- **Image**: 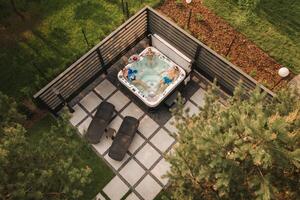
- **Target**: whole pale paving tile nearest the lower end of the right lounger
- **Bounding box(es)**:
[120,159,145,186]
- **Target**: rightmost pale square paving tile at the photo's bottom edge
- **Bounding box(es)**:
[135,175,162,200]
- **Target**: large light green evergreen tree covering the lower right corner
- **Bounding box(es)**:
[168,86,300,200]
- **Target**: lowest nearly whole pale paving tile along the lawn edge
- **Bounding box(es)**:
[103,176,129,200]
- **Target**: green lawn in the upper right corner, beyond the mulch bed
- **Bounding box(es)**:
[204,0,300,74]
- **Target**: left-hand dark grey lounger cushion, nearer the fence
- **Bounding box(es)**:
[85,102,115,144]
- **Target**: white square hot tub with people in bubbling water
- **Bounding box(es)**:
[118,47,186,108]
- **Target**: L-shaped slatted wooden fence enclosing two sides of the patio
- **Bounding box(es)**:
[34,7,274,114]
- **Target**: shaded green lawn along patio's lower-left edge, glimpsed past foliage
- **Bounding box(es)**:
[28,115,114,200]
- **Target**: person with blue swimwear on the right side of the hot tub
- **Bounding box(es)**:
[157,65,179,93]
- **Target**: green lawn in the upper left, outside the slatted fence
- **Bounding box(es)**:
[0,0,160,98]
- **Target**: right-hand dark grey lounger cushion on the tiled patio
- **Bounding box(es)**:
[108,116,139,161]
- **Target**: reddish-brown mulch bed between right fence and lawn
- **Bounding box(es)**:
[158,0,293,91]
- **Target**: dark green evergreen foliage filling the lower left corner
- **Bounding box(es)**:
[0,93,91,200]
